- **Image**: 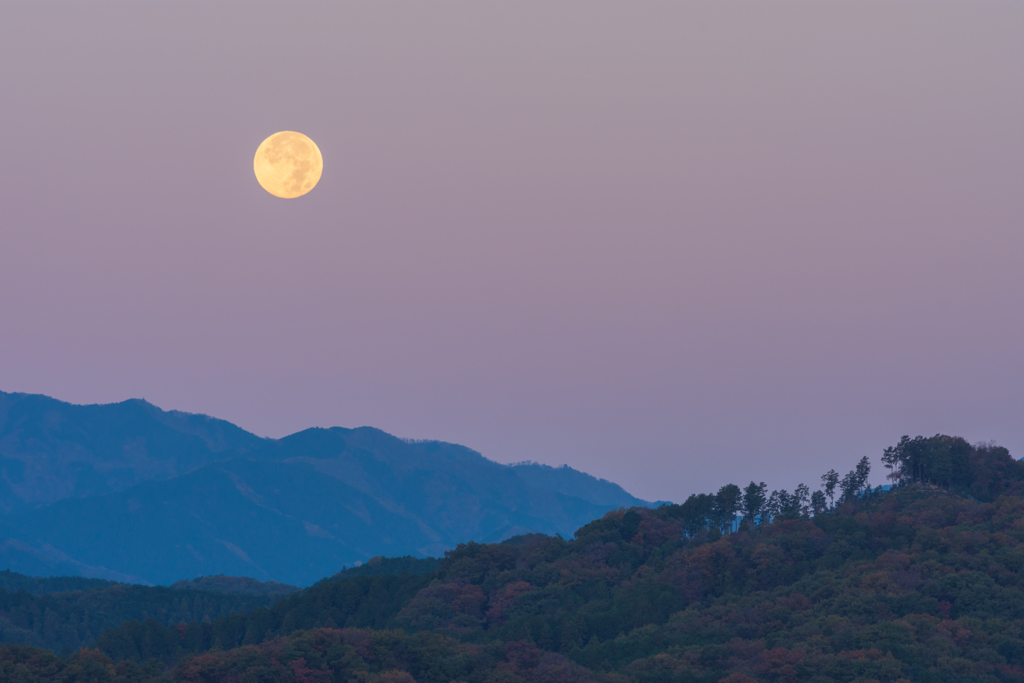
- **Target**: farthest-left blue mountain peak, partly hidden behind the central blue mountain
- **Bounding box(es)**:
[0,392,264,512]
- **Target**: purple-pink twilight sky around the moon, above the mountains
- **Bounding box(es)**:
[0,0,1024,501]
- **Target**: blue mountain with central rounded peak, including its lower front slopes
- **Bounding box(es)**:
[6,436,612,586]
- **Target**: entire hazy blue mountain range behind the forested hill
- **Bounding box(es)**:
[0,392,651,586]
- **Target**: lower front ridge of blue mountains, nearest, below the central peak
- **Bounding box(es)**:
[9,459,428,585]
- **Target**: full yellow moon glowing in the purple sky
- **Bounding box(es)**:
[253,130,324,200]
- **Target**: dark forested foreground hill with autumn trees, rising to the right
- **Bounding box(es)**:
[9,436,1024,683]
